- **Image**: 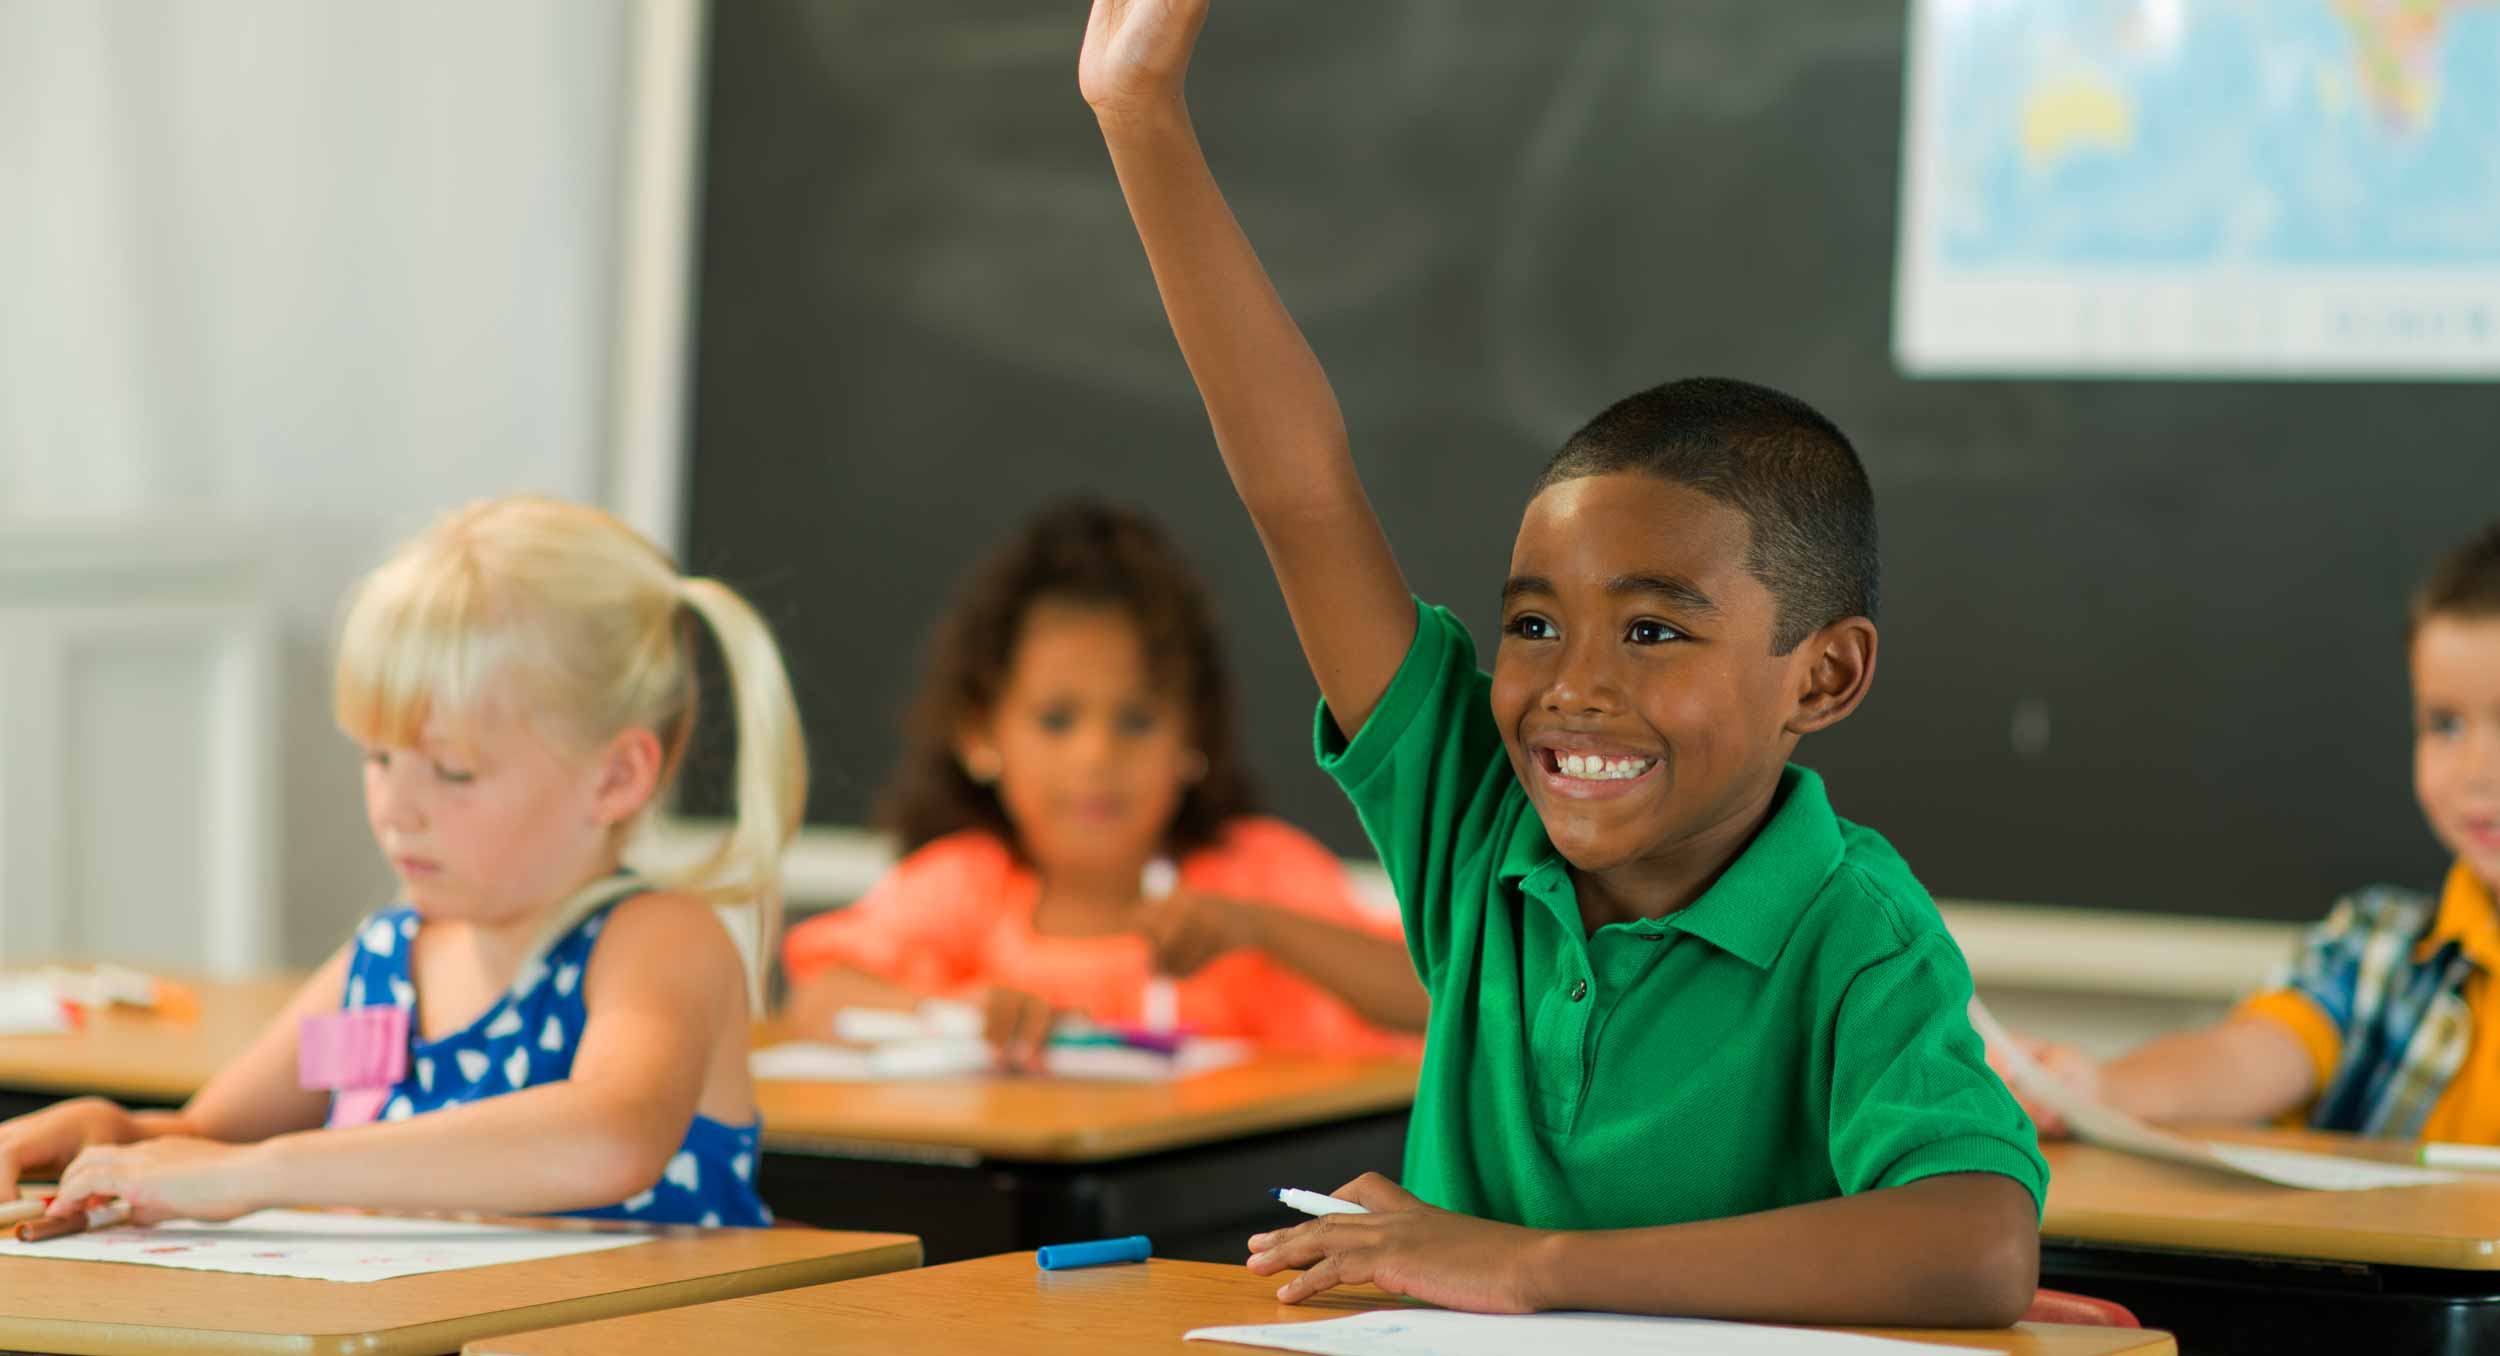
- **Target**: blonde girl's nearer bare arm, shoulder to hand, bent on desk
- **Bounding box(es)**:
[55,896,745,1221]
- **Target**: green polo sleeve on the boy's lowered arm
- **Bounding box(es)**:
[1830,931,2048,1208]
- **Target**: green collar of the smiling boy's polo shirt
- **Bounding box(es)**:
[1495,763,1843,971]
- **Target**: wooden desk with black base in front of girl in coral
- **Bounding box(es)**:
[758,1058,1415,1261]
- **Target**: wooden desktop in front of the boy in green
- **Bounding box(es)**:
[468,1253,2175,1356]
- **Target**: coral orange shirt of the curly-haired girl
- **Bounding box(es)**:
[783,818,1423,1056]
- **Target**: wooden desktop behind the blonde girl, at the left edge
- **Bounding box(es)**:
[0,976,305,1118]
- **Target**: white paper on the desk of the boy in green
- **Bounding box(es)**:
[1183,1308,2003,1356]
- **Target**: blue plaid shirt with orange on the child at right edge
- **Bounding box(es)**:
[2243,863,2495,1138]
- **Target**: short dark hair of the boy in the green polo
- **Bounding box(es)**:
[1538,378,1878,655]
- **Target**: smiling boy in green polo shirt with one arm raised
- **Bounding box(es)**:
[1080,0,2048,1326]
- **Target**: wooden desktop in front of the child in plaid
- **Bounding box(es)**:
[2040,1128,2500,1271]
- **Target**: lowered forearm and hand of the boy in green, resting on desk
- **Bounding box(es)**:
[1250,1173,2040,1328]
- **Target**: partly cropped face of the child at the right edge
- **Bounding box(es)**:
[2413,615,2500,888]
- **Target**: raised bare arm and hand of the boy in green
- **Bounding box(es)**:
[1078,0,1415,738]
